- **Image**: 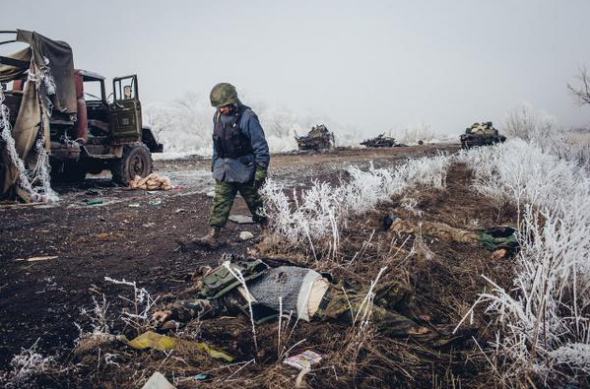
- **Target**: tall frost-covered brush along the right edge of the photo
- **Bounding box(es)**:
[458,140,590,384]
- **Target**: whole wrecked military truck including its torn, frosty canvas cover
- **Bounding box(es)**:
[0,30,163,201]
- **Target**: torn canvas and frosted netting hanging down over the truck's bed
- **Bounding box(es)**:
[0,30,77,202]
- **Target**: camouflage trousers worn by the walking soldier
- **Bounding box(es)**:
[209,181,266,227]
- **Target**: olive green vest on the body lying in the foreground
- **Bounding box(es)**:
[199,259,268,299]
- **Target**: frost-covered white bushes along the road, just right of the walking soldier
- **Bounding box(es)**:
[262,155,450,256]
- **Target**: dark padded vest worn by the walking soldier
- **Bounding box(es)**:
[213,104,252,159]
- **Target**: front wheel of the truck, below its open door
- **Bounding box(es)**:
[111,143,153,185]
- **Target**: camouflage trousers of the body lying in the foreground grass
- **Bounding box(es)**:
[314,281,446,345]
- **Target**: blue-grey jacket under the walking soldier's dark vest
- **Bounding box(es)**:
[212,103,270,184]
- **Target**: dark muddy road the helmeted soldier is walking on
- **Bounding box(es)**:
[0,145,458,369]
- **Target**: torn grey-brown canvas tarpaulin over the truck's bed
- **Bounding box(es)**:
[0,30,77,202]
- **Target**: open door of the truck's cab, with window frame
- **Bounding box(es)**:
[109,75,141,143]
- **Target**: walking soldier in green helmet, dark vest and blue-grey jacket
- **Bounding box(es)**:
[196,83,270,249]
